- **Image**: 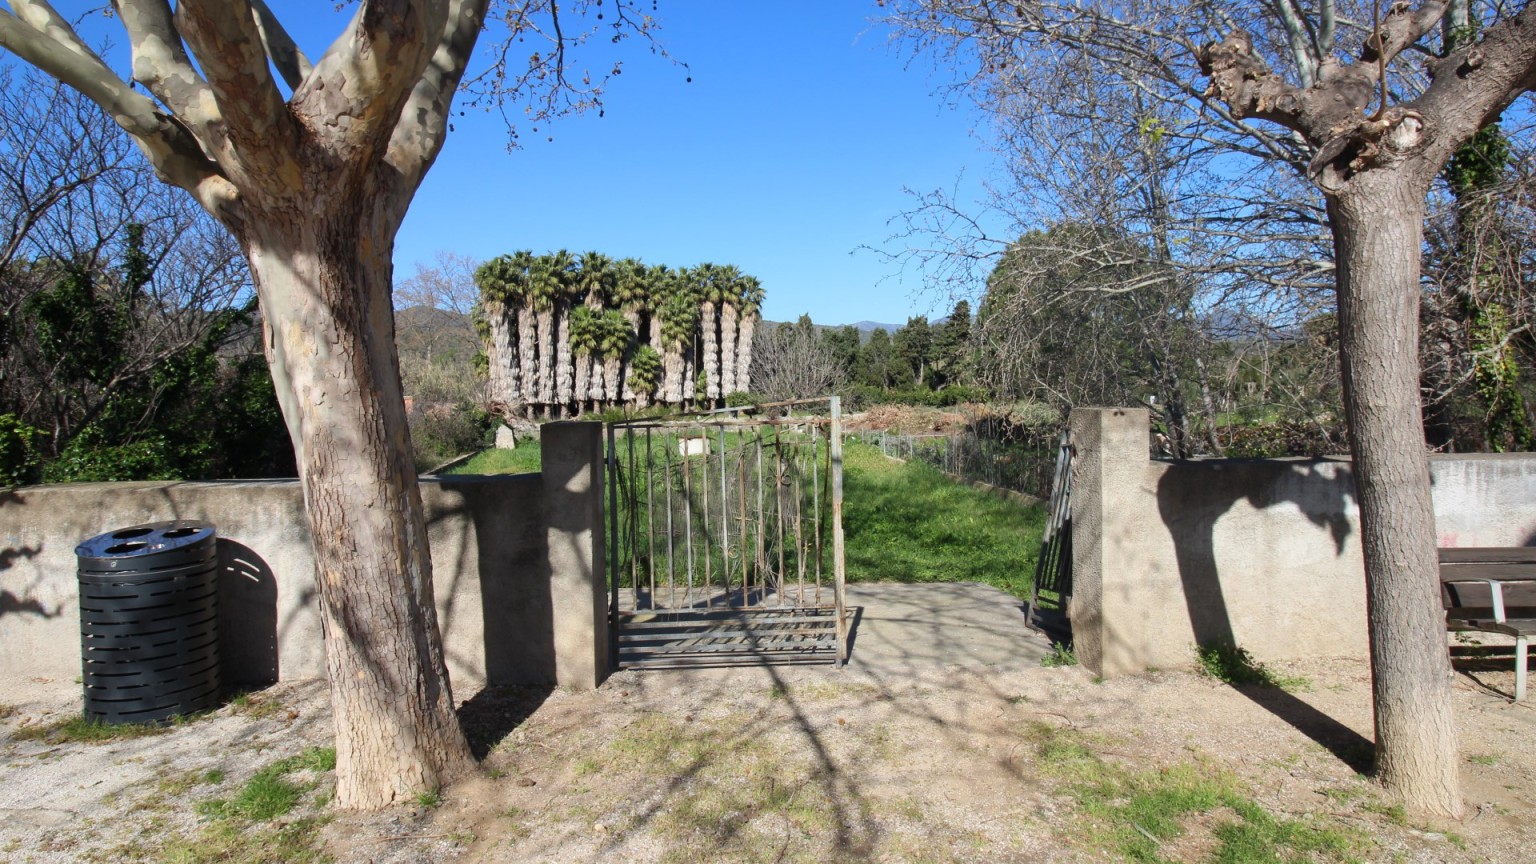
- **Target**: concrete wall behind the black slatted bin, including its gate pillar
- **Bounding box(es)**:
[0,423,608,696]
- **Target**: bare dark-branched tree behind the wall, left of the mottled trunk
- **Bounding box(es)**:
[0,68,250,457]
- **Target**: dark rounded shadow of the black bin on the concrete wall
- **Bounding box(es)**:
[218,537,278,687]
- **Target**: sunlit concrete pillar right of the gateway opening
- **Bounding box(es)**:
[1068,407,1157,678]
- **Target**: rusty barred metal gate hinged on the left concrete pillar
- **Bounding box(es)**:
[607,397,848,667]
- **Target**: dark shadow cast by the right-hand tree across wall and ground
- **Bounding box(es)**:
[1157,460,1372,770]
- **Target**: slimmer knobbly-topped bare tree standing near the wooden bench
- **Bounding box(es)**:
[895,0,1536,816]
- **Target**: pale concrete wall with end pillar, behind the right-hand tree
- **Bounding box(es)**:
[1071,409,1536,676]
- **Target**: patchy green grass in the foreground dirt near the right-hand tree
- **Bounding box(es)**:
[1025,723,1364,864]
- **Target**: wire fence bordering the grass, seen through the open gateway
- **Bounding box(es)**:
[862,430,1058,498]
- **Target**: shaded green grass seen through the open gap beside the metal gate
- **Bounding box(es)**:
[843,441,1046,598]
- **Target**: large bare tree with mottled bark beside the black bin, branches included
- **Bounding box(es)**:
[0,0,666,807]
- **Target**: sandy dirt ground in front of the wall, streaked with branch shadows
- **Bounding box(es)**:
[0,586,1536,864]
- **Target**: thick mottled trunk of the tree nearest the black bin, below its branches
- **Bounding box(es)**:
[241,209,473,809]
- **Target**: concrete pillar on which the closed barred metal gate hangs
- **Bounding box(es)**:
[539,423,608,690]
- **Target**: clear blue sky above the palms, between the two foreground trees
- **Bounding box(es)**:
[327,0,991,324]
